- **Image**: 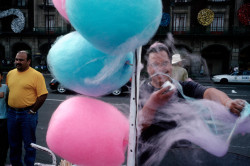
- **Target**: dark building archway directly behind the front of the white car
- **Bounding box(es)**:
[201,44,231,75]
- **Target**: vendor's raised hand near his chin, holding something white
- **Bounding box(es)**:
[146,86,176,110]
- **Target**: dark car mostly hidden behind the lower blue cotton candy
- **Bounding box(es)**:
[49,79,131,96]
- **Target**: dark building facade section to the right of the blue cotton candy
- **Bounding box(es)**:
[153,0,250,76]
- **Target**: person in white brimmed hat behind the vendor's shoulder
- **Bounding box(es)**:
[172,54,188,81]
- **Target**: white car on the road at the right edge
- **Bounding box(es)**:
[212,70,250,83]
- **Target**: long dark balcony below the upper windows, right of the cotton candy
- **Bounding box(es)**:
[156,26,250,36]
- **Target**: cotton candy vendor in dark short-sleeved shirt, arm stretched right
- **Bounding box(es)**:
[138,43,245,165]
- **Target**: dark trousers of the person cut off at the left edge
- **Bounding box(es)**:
[0,119,9,166]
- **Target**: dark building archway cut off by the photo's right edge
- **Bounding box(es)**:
[238,45,250,70]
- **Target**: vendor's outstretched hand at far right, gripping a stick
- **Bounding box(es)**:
[225,99,246,116]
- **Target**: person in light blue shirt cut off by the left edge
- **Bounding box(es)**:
[0,70,9,166]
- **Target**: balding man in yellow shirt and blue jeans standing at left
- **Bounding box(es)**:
[6,51,48,166]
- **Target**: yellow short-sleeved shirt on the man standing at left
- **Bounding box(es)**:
[6,67,48,108]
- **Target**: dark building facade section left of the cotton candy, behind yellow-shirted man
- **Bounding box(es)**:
[0,0,72,70]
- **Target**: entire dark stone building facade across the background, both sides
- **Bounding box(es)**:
[0,0,250,76]
